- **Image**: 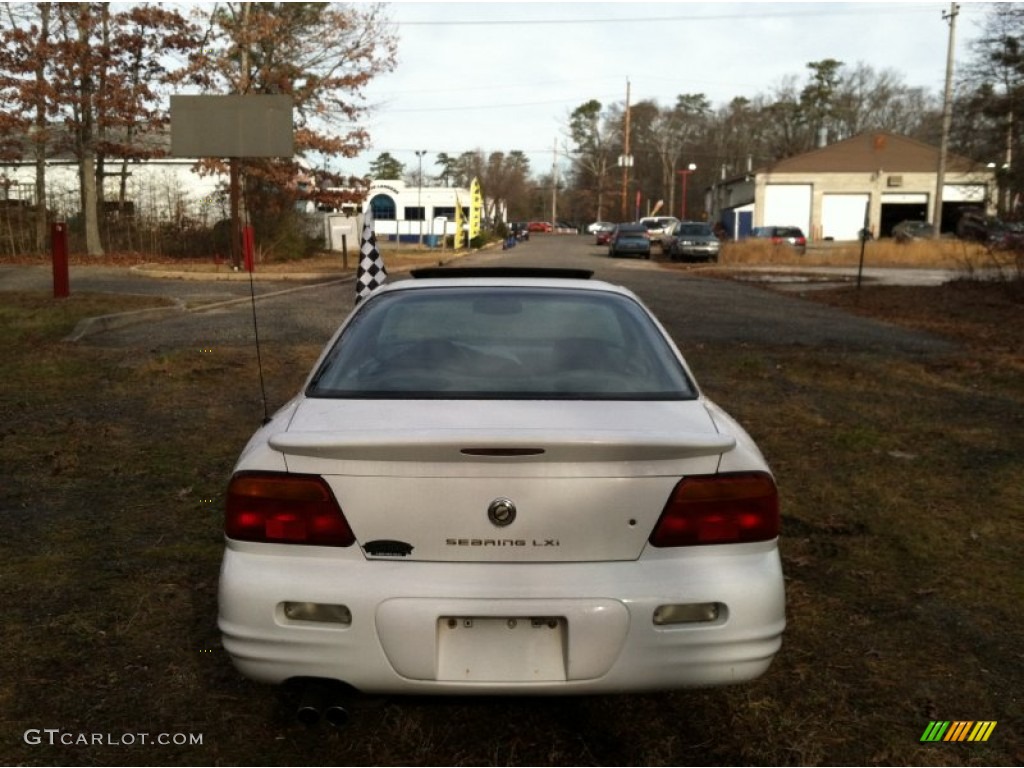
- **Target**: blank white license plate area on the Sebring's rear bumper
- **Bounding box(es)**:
[436,616,567,683]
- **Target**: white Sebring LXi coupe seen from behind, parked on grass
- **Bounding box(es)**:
[219,268,785,722]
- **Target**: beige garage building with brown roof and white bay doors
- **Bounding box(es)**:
[706,131,995,242]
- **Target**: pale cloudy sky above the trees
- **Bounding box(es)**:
[344,0,989,180]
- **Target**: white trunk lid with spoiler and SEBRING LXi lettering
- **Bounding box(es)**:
[270,399,735,561]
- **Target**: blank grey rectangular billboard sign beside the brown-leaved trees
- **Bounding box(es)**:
[171,94,295,158]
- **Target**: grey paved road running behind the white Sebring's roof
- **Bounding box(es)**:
[0,236,951,354]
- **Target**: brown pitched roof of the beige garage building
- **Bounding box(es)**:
[761,131,982,173]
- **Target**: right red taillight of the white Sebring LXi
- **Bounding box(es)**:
[649,472,779,547]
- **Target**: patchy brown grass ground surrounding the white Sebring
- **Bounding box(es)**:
[0,268,1024,765]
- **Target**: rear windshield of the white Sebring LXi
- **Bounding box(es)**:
[306,286,696,399]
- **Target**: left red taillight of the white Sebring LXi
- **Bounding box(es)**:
[224,472,355,547]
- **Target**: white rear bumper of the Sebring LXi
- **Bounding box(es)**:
[218,542,785,694]
